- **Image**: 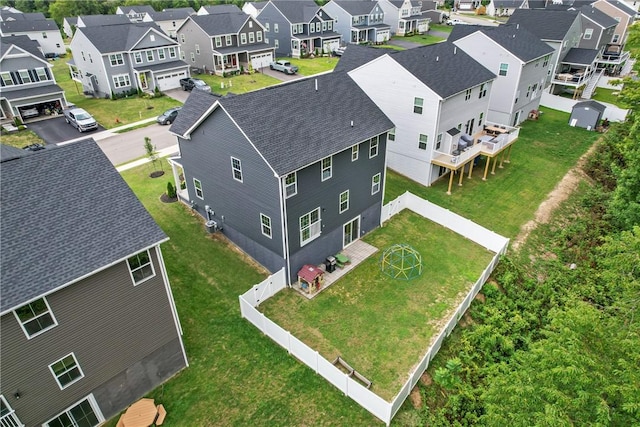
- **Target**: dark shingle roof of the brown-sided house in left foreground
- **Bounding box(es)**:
[0,139,167,313]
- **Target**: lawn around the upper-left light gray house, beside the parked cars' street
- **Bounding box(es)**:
[53,56,181,129]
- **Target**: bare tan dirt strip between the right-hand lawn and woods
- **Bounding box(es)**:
[511,142,597,250]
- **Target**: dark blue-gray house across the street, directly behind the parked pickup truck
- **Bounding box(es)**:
[257,0,343,58]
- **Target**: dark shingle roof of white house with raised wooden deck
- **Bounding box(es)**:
[390,42,496,98]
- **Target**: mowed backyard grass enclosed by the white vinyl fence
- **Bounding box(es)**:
[259,210,493,400]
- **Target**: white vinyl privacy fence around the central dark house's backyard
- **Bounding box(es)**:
[239,192,509,425]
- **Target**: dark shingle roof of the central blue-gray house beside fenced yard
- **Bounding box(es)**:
[170,72,394,176]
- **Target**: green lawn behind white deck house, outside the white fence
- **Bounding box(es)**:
[385,108,600,238]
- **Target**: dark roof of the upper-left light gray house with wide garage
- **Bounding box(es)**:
[77,22,169,53]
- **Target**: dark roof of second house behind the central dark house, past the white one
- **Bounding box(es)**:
[447,24,553,62]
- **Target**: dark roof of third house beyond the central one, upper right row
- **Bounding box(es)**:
[507,9,579,41]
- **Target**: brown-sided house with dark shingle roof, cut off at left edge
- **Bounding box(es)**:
[0,139,187,427]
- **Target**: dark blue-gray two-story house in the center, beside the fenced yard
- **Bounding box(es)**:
[170,72,394,281]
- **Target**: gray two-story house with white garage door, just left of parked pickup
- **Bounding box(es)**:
[177,12,275,76]
